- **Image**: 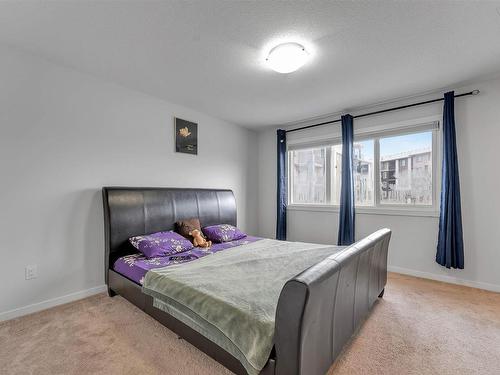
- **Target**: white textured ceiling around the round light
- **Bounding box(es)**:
[0,0,500,128]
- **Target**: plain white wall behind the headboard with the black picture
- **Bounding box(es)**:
[0,46,257,320]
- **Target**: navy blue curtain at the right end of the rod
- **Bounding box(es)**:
[436,91,464,269]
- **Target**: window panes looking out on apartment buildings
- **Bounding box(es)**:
[288,122,438,213]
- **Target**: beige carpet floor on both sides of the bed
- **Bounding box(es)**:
[0,274,500,375]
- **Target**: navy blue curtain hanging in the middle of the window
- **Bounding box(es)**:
[337,115,354,246]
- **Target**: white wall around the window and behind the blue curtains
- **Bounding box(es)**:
[259,79,500,291]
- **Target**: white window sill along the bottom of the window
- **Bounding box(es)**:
[287,204,439,217]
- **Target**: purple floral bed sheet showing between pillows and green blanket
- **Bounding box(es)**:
[113,236,261,285]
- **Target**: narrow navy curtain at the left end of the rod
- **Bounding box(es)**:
[276,129,287,240]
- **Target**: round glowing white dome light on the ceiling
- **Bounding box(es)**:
[266,42,309,73]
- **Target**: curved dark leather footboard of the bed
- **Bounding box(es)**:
[275,229,391,375]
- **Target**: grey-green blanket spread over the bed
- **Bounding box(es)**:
[143,239,342,375]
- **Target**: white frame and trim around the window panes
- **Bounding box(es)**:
[287,116,442,217]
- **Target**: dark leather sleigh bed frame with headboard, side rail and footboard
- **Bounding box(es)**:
[102,187,391,375]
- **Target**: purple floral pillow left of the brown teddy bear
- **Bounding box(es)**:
[128,231,193,258]
